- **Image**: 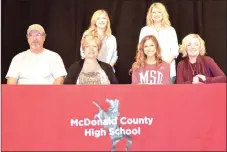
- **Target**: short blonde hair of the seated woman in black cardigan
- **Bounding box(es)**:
[81,35,102,51]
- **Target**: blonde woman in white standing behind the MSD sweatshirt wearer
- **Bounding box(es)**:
[139,3,179,83]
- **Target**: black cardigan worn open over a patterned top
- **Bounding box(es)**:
[64,60,118,84]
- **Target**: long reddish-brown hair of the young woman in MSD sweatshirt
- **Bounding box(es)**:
[130,35,162,72]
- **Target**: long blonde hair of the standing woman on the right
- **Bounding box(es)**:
[146,2,171,27]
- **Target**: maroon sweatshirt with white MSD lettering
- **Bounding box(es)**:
[132,61,170,84]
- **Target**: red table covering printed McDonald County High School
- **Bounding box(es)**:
[2,84,226,151]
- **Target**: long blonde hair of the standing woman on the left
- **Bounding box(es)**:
[84,9,112,36]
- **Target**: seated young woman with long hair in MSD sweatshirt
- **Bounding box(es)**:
[130,35,170,84]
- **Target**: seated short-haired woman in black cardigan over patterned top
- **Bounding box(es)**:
[64,35,118,85]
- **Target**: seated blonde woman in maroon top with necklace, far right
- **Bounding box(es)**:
[177,34,226,84]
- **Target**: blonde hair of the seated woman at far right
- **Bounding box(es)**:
[180,33,206,57]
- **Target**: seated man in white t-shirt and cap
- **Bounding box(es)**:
[6,24,67,84]
